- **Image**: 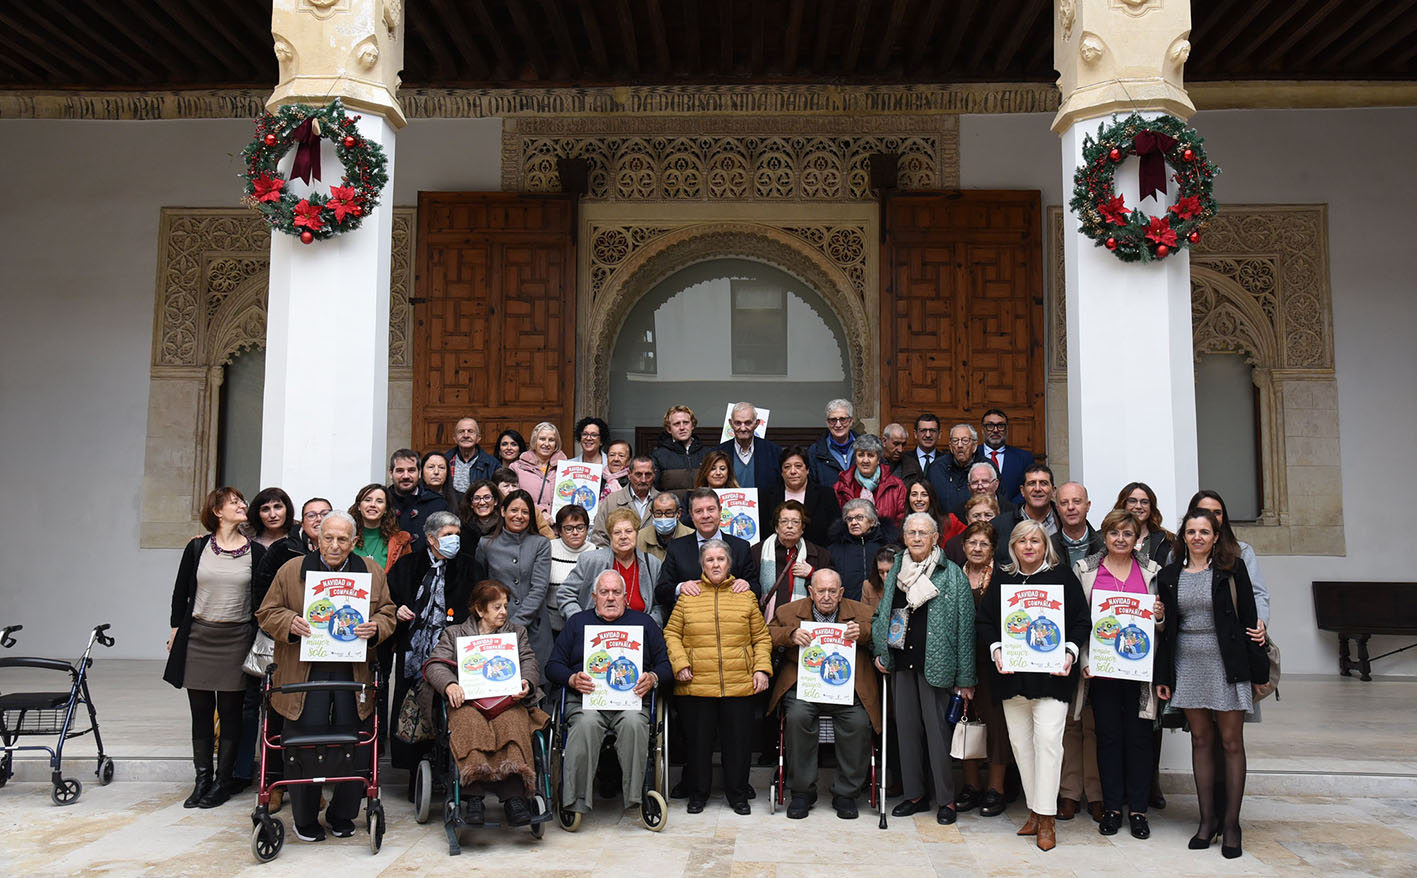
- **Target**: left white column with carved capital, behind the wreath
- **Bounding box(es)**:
[261,0,405,508]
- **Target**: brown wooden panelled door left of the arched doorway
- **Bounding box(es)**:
[412,193,575,452]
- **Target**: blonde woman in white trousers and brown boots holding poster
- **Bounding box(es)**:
[975,518,1091,851]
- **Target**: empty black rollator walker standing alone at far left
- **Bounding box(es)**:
[0,625,113,804]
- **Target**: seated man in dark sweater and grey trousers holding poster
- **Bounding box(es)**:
[546,569,673,814]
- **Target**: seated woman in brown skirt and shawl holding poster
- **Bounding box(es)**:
[424,581,551,826]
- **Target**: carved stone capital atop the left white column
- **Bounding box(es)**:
[266,0,407,129]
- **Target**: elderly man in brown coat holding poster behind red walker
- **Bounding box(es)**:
[256,510,394,841]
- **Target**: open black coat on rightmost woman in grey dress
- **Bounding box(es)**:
[1152,559,1270,688]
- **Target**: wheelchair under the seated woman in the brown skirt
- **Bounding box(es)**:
[414,659,554,857]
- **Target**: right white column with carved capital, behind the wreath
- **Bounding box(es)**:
[1053,0,1197,527]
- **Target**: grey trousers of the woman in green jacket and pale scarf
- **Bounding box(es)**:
[890,671,955,804]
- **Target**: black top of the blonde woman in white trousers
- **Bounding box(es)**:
[975,562,1093,704]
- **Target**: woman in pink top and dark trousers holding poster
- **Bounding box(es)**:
[1073,508,1166,838]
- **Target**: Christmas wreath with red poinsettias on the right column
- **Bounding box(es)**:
[1068,113,1220,262]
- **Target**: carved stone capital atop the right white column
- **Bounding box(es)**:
[1053,0,1196,133]
